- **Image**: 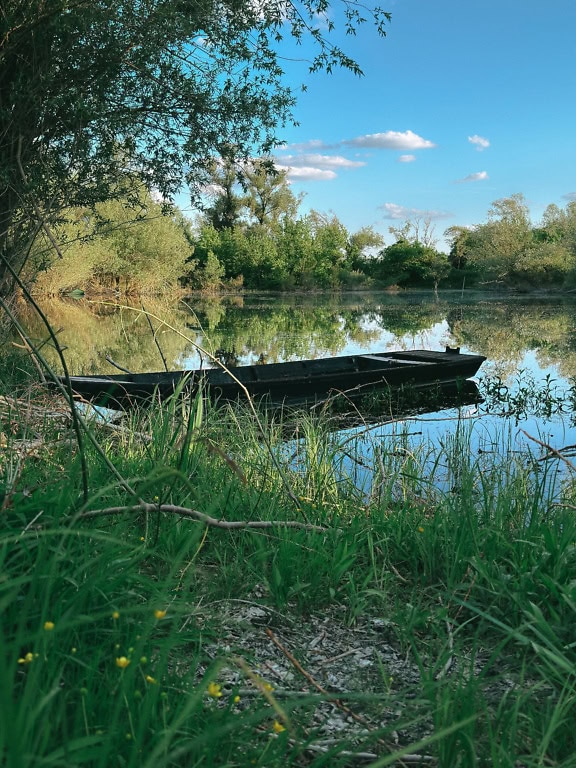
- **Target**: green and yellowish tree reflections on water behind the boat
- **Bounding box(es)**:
[13,294,576,377]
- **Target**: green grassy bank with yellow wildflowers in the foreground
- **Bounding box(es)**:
[0,380,576,768]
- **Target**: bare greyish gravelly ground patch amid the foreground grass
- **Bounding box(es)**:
[189,600,521,768]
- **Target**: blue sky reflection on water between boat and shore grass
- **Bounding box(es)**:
[338,405,574,503]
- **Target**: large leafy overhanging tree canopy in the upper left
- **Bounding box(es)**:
[0,0,389,292]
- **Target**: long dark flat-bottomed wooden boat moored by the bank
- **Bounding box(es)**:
[55,347,486,408]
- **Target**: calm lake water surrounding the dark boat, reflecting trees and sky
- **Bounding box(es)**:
[16,292,576,480]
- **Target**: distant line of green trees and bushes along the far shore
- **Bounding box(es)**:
[27,165,576,294]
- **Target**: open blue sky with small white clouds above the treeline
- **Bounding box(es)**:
[266,0,576,248]
